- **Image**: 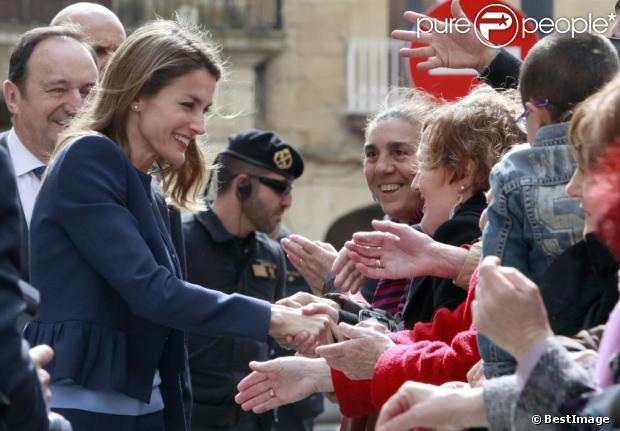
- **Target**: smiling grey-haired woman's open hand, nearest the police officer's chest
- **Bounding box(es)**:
[280,235,338,295]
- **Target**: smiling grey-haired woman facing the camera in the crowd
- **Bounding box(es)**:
[282,88,437,308]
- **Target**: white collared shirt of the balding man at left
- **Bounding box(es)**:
[7,129,45,229]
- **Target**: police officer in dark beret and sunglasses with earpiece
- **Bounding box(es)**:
[183,130,304,431]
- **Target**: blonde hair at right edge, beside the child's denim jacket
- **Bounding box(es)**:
[568,75,620,170]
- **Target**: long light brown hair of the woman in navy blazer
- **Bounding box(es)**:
[52,19,223,210]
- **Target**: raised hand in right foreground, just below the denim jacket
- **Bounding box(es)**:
[472,256,553,360]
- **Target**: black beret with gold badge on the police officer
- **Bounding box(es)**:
[220,129,304,179]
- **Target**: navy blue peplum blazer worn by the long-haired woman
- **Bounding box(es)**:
[25,135,270,429]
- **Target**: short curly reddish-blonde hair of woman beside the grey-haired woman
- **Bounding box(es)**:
[418,90,526,192]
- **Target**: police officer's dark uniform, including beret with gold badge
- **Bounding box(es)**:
[183,130,303,431]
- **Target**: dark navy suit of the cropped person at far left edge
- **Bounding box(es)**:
[0,147,48,431]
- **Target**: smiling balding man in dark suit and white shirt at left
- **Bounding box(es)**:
[0,27,97,280]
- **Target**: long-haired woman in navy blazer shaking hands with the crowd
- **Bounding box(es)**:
[25,20,326,431]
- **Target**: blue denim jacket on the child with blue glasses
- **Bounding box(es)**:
[478,123,584,378]
